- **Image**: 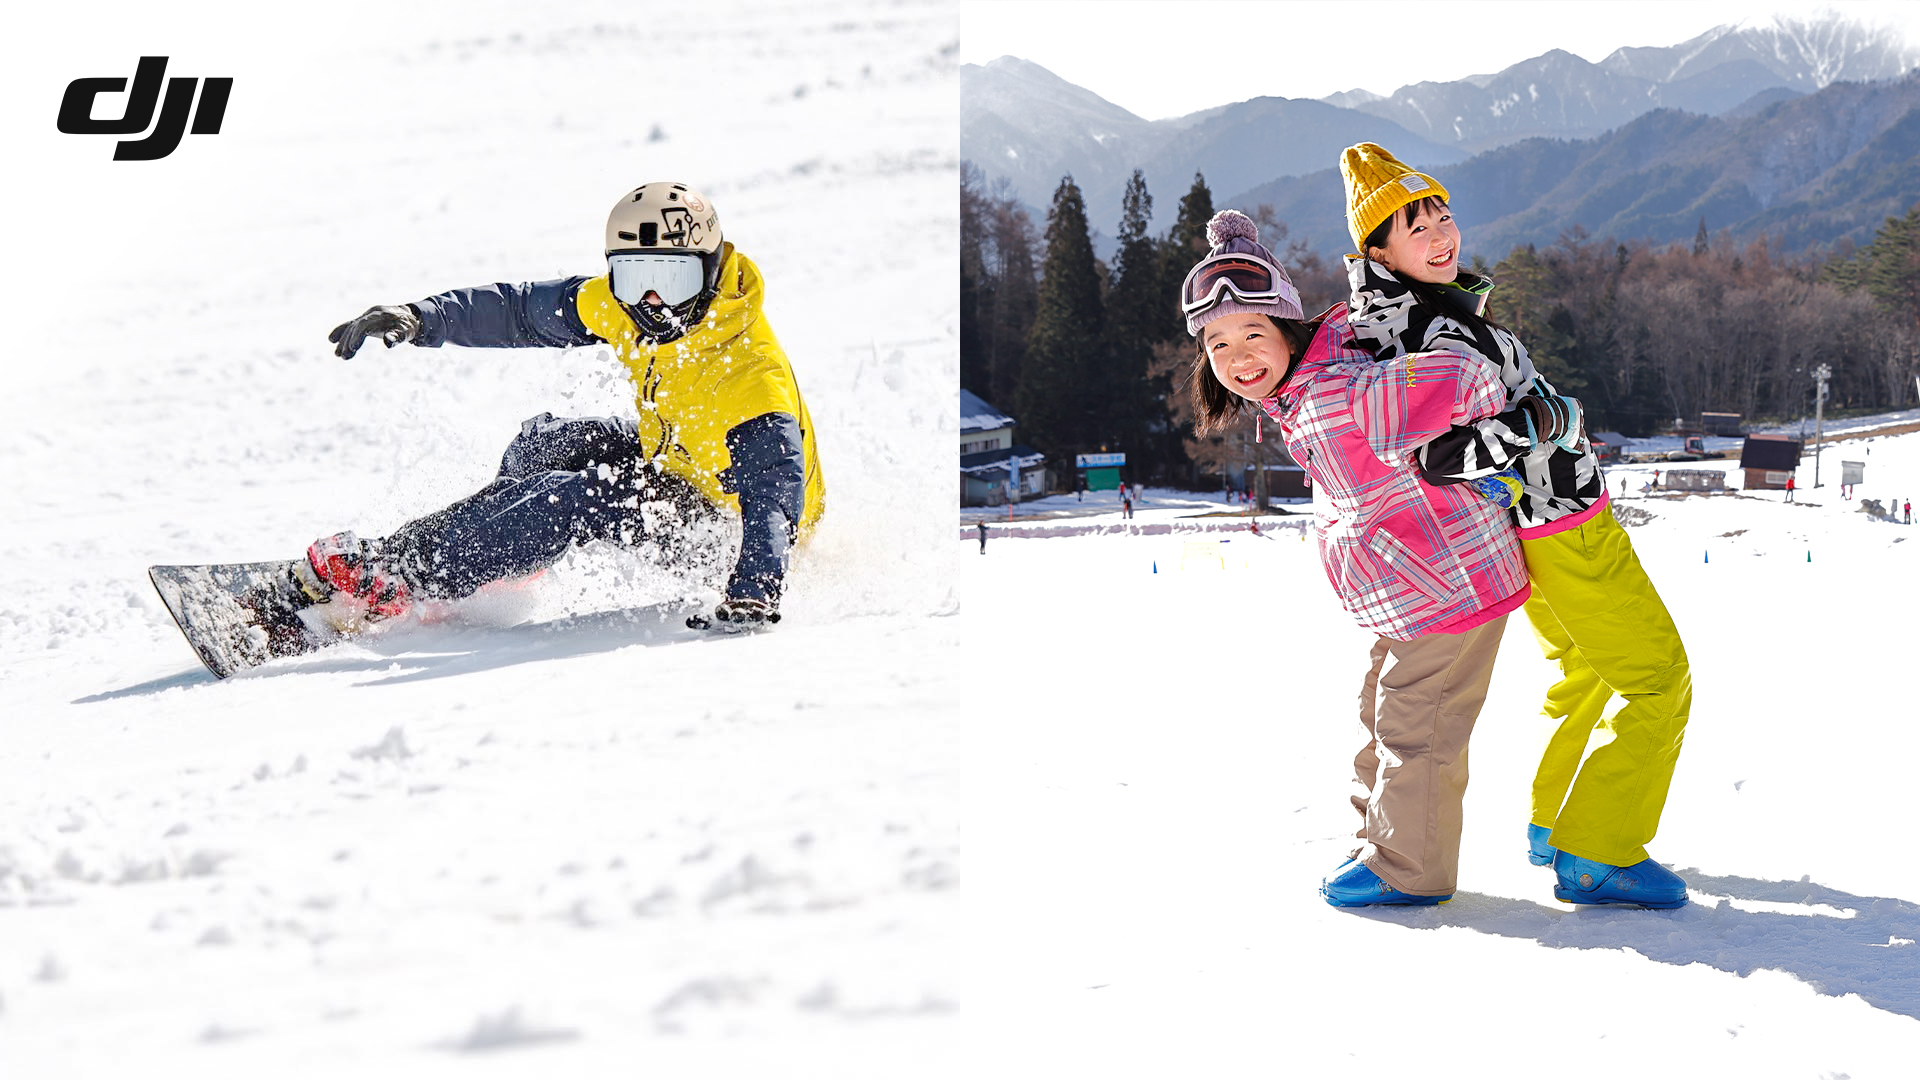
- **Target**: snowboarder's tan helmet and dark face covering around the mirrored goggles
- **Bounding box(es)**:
[607,181,728,342]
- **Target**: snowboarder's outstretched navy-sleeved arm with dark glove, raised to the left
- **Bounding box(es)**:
[328,277,601,359]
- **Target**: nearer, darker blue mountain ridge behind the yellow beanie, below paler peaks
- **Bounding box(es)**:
[1213,71,1920,261]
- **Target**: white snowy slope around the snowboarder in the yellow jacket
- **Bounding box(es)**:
[0,0,964,1078]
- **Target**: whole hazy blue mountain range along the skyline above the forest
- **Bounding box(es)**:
[960,17,1920,258]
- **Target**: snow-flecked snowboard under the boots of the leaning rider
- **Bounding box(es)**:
[146,561,340,678]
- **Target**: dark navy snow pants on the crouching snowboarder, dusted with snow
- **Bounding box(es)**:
[384,413,716,600]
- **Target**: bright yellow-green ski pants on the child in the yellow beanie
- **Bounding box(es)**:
[1521,511,1693,867]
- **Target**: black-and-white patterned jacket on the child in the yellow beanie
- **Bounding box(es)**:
[1346,256,1607,538]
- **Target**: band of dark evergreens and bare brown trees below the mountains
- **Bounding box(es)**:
[960,163,1920,486]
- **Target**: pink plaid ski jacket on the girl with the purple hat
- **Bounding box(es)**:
[1261,304,1528,640]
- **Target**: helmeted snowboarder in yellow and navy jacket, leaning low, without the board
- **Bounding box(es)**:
[312,183,826,626]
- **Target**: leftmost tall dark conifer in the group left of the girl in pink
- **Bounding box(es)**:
[1014,175,1106,457]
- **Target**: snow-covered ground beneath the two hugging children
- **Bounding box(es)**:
[960,424,1920,1080]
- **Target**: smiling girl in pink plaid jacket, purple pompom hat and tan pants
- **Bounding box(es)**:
[1181,209,1528,907]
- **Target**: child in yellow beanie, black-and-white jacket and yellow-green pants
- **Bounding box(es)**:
[1340,142,1693,907]
